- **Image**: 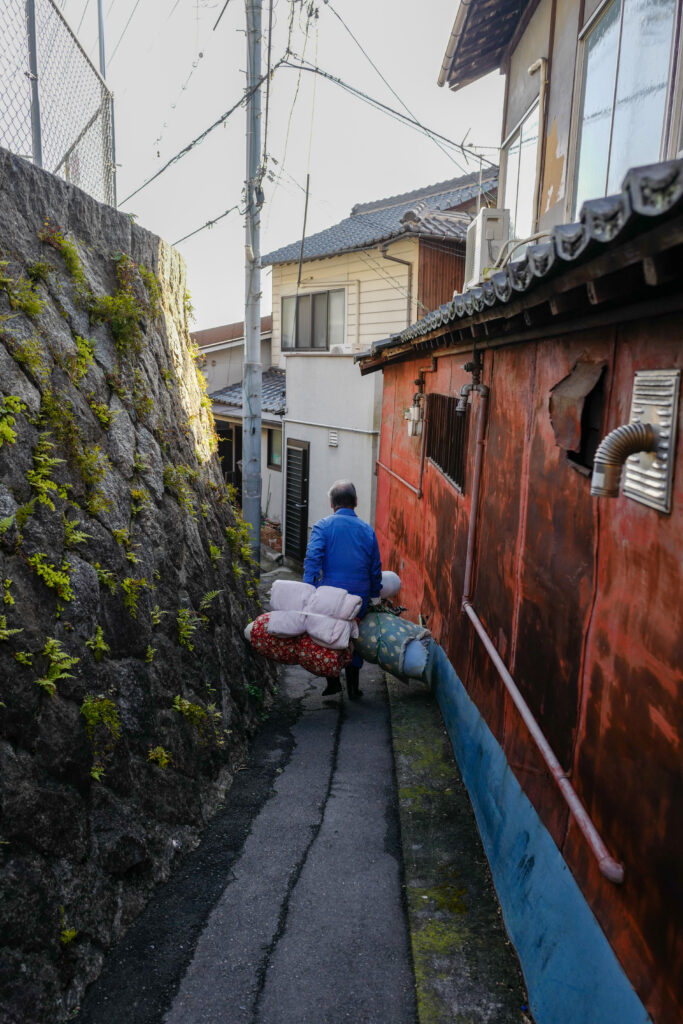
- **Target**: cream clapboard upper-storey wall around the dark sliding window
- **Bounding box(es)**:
[272,239,420,367]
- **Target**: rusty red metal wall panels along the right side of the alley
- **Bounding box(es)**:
[377,317,683,1024]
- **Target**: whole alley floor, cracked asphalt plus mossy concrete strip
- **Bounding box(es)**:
[70,569,528,1024]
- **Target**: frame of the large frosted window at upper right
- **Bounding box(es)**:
[564,0,683,222]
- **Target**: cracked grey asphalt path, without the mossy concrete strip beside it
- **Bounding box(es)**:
[77,666,417,1024]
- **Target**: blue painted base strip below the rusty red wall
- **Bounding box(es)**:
[429,644,651,1024]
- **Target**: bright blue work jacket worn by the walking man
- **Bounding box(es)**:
[303,509,382,614]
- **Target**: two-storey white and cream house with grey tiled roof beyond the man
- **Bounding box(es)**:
[262,167,498,560]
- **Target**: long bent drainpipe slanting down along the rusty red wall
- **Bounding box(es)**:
[461,375,624,884]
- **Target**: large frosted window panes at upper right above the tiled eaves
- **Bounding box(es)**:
[573,0,676,216]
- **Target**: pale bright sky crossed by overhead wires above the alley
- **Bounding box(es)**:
[57,0,504,330]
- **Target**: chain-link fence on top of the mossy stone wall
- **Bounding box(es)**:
[0,0,116,206]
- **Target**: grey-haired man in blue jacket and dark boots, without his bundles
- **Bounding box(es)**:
[303,480,382,700]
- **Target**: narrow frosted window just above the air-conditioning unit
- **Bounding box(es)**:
[504,102,539,240]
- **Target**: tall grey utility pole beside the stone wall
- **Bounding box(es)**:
[242,0,263,566]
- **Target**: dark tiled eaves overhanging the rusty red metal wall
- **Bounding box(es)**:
[355,160,683,375]
